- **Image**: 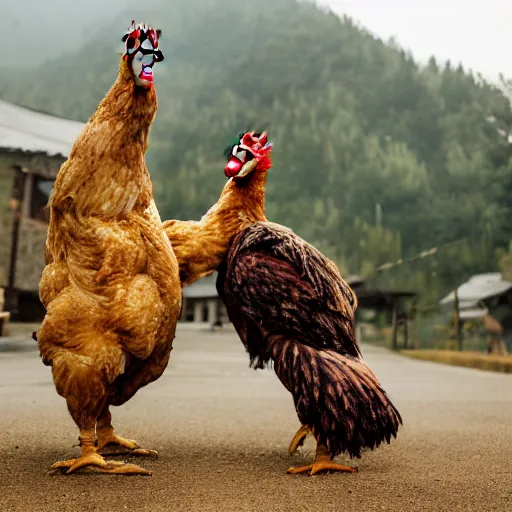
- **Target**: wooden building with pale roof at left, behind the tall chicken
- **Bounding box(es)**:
[0,100,84,321]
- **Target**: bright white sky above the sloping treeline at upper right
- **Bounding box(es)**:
[326,0,512,80]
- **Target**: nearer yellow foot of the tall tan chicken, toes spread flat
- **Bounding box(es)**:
[51,429,151,475]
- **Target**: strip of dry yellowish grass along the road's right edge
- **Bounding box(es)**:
[400,350,512,373]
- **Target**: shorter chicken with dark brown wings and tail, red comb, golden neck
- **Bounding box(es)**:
[166,133,401,474]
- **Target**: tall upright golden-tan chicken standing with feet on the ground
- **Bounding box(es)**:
[37,22,181,474]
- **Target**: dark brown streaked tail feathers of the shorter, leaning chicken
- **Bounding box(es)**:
[269,336,402,457]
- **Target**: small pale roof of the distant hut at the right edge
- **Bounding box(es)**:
[439,272,512,309]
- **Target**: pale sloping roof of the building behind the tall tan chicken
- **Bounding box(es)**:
[0,100,84,157]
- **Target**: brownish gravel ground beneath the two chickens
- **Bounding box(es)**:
[0,328,512,512]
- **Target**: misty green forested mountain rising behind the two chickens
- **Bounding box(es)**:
[0,0,512,300]
